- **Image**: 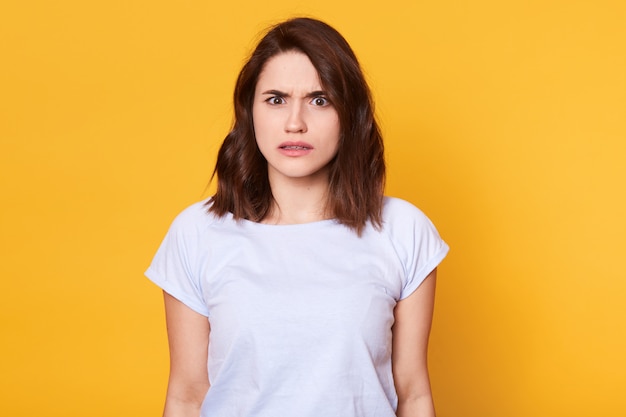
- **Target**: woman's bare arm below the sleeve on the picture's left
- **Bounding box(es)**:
[163,292,210,417]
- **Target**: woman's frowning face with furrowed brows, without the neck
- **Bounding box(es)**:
[252,52,340,185]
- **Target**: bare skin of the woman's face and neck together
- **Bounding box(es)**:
[252,52,340,224]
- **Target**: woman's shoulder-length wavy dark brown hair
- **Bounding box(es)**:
[207,18,385,235]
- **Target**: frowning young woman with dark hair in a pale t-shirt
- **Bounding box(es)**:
[146,18,448,417]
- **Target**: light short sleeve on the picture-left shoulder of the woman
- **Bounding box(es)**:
[145,203,209,317]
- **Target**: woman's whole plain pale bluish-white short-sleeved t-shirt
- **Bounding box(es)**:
[146,197,448,417]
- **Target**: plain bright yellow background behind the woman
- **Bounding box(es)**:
[0,0,626,417]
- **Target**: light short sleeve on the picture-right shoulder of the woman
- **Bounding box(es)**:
[386,199,449,300]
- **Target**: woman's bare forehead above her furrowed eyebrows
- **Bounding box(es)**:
[257,51,321,90]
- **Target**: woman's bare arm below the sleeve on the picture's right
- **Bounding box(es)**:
[391,269,437,417]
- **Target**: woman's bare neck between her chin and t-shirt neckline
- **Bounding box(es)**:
[263,170,332,224]
